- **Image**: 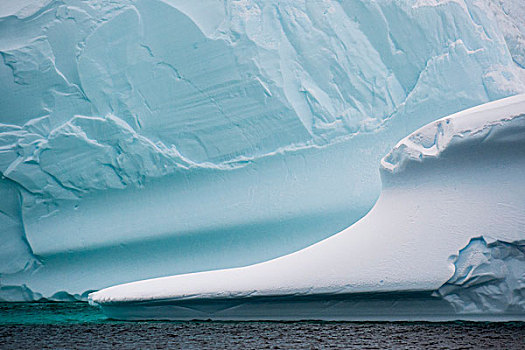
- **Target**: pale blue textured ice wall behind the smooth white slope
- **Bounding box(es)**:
[0,0,525,299]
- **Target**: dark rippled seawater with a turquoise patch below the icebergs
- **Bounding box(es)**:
[0,303,525,349]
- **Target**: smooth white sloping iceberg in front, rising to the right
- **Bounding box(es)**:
[89,95,525,320]
